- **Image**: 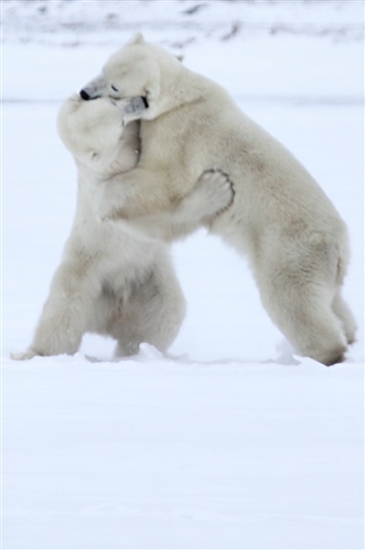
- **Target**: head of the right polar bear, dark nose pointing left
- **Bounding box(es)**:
[80,34,182,121]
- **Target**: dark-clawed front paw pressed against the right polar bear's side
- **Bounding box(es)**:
[196,170,235,221]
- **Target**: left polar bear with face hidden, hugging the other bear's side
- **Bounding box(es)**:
[12,94,232,359]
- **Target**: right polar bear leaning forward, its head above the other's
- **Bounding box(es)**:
[80,34,356,365]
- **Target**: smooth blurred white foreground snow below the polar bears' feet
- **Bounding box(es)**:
[3,358,362,549]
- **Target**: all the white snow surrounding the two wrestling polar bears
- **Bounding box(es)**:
[1,0,364,550]
